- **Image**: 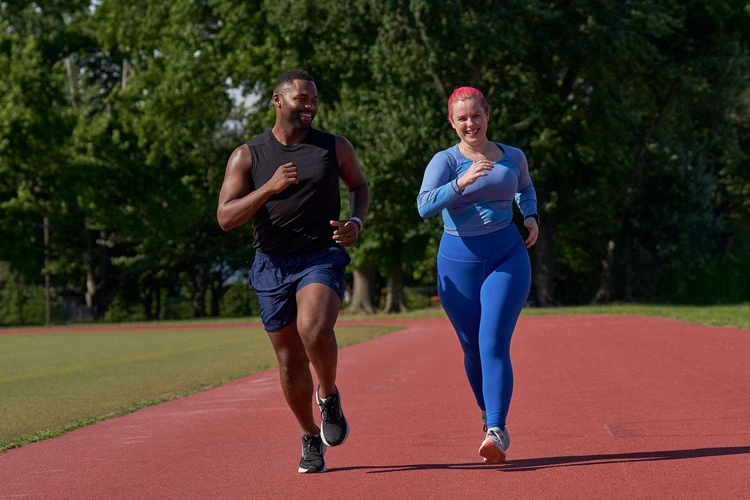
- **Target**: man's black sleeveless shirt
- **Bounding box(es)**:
[247,128,341,255]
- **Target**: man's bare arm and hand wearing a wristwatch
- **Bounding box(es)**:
[331,136,370,247]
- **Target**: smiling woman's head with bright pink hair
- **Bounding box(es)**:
[448,87,490,146]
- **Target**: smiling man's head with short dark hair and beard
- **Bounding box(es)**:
[273,71,318,129]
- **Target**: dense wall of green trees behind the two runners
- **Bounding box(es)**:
[0,0,750,322]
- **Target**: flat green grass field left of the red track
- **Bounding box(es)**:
[0,325,397,452]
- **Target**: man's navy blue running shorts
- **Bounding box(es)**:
[250,245,351,332]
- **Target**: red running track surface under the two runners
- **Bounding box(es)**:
[0,316,750,500]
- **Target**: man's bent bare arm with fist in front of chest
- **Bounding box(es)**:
[216,144,299,231]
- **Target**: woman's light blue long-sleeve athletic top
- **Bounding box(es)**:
[417,143,537,236]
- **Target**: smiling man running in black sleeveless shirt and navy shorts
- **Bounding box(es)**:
[217,71,370,473]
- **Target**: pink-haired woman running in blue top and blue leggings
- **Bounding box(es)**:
[417,87,539,463]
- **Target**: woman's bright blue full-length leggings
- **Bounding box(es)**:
[437,224,531,427]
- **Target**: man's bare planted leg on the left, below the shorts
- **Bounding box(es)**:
[268,321,320,435]
